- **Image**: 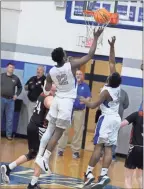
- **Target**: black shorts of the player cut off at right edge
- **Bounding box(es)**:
[125,144,143,169]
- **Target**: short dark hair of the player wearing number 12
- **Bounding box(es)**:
[51,47,65,63]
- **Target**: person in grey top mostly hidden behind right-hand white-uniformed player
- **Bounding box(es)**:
[112,89,129,161]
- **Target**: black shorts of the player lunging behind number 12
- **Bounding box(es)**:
[27,121,46,151]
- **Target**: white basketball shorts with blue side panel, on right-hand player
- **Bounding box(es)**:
[94,115,121,146]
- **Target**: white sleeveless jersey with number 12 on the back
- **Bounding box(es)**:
[49,62,77,99]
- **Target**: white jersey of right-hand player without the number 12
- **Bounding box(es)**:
[100,85,120,114]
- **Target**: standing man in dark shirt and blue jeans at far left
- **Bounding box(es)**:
[1,63,22,140]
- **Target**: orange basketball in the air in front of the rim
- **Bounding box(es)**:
[94,8,111,24]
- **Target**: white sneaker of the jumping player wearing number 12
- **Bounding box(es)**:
[35,156,51,175]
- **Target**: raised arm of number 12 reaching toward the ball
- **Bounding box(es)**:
[70,27,104,69]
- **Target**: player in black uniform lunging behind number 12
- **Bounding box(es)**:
[1,85,56,189]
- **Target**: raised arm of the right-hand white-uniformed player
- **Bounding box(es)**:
[108,37,116,75]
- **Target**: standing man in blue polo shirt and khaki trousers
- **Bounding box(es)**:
[58,70,91,158]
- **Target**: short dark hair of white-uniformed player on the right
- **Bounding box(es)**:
[108,72,121,88]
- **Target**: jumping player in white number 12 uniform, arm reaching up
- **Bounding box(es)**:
[36,27,103,173]
